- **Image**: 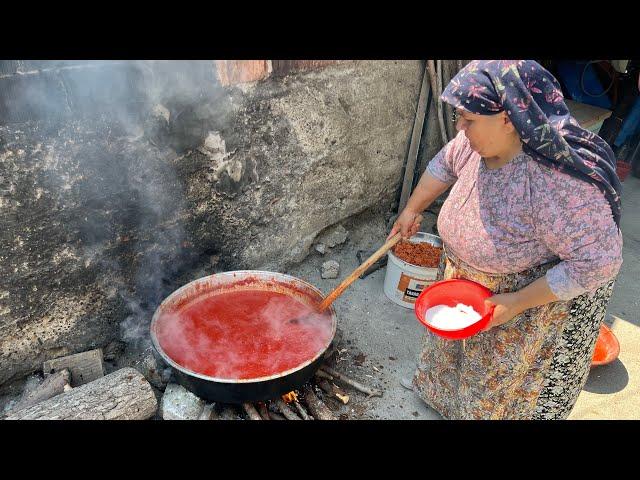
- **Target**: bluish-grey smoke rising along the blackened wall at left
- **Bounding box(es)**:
[0,61,230,347]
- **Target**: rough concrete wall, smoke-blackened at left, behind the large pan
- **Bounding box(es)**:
[0,61,421,383]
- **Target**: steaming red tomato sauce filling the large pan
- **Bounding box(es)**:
[155,290,332,380]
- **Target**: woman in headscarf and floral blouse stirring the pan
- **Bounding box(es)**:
[390,60,622,419]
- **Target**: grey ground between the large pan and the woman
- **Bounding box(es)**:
[285,208,440,420]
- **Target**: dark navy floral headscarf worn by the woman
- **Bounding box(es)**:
[441,60,622,226]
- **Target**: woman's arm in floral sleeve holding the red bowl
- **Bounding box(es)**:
[485,167,622,330]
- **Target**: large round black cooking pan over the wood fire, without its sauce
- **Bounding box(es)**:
[151,270,337,403]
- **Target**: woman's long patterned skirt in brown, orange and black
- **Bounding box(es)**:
[413,248,614,420]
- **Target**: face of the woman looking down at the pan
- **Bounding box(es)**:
[456,109,517,158]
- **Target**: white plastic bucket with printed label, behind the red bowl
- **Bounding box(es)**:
[384,232,442,308]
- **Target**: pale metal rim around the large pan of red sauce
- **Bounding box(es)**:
[149,270,337,384]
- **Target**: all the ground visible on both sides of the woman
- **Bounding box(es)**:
[286,177,640,420]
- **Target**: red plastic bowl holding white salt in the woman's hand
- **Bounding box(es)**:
[414,279,494,340]
